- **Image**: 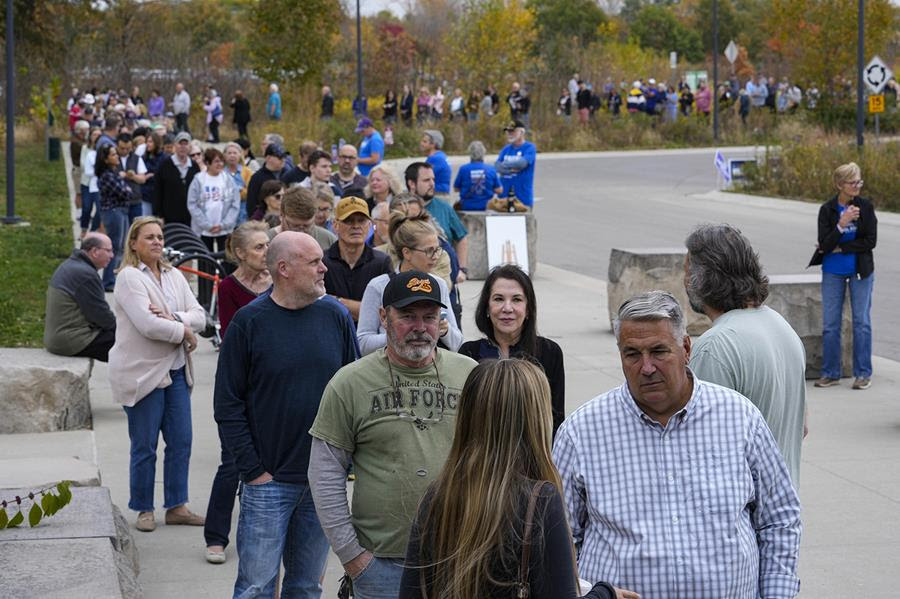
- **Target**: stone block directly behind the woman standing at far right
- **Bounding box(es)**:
[766,273,853,379]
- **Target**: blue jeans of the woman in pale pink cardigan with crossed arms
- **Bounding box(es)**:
[125,367,193,512]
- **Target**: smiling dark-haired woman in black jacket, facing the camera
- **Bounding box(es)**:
[459,264,566,435]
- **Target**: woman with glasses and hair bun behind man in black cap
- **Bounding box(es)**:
[356,211,463,355]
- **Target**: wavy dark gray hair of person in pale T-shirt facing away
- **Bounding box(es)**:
[684,225,769,313]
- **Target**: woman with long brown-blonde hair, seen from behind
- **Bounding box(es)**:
[400,359,637,599]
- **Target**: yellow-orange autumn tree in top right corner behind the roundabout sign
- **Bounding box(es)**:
[764,0,898,89]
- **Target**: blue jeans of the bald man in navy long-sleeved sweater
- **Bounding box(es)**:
[234,480,328,599]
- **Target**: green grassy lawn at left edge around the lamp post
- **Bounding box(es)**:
[0,143,72,347]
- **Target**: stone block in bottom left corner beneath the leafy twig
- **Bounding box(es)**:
[0,487,142,598]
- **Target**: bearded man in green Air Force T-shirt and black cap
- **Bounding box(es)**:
[308,271,475,599]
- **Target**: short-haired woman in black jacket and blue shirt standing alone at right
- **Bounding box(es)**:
[809,162,878,390]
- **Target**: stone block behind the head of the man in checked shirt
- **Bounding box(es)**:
[606,248,712,335]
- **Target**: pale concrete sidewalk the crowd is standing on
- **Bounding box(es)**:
[91,264,900,599]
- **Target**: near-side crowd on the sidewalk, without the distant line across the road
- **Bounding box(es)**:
[45,81,877,599]
